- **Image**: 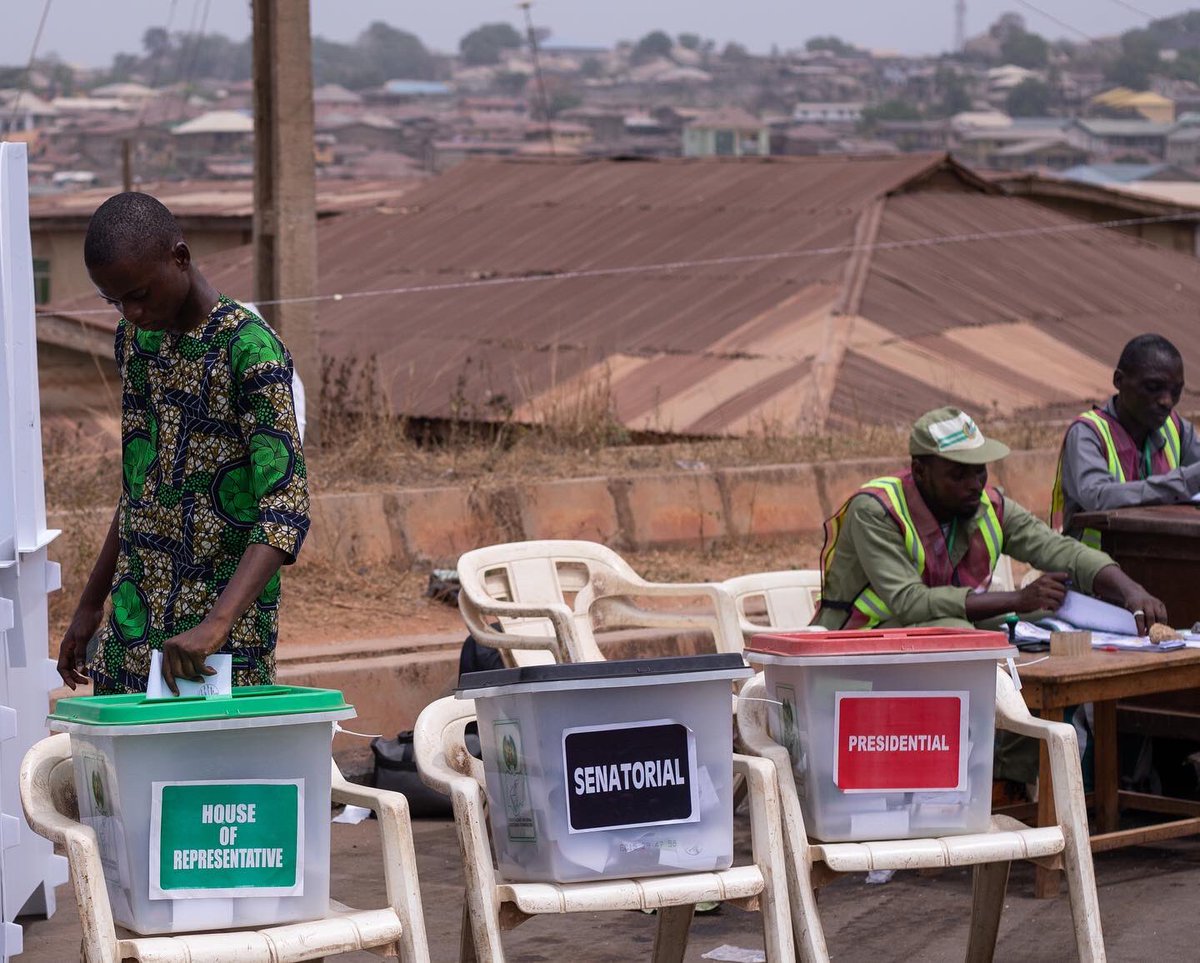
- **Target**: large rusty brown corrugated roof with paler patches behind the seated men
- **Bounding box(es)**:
[39,155,1200,435]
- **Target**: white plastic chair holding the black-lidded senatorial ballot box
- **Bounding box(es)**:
[414,696,794,963]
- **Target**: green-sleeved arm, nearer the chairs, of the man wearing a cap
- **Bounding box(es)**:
[841,495,974,626]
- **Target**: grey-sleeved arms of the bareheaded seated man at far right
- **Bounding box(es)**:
[1062,424,1200,512]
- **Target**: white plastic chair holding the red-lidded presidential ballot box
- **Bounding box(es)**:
[738,669,1105,963]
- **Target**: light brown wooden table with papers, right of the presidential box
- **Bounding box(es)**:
[1019,648,1200,898]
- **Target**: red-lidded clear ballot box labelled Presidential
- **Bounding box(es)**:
[746,628,1016,842]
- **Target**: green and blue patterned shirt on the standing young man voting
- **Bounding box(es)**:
[89,297,308,694]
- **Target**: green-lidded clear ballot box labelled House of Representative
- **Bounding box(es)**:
[47,686,355,934]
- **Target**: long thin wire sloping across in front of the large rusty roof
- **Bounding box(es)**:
[37,211,1200,317]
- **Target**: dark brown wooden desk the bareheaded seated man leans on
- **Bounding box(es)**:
[1072,504,1200,628]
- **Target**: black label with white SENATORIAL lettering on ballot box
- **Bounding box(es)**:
[563,719,700,832]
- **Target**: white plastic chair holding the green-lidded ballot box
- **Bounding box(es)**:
[20,732,430,963]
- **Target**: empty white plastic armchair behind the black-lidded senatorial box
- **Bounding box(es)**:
[458,539,742,665]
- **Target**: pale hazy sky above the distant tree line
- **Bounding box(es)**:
[0,0,1166,66]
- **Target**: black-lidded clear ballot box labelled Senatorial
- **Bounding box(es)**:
[457,653,751,883]
